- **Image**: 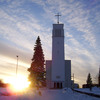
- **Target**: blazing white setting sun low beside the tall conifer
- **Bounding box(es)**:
[10,75,30,91]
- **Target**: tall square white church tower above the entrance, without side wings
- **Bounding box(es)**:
[51,15,65,82]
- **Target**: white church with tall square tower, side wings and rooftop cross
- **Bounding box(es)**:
[46,14,71,89]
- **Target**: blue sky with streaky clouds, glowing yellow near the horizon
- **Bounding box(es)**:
[0,0,100,85]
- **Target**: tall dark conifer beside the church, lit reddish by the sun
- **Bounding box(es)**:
[28,36,45,86]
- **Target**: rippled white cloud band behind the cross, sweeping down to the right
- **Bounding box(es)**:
[34,0,96,47]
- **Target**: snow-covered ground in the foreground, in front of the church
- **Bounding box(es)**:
[0,88,100,100]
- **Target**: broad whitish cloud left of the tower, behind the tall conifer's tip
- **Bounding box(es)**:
[0,0,51,59]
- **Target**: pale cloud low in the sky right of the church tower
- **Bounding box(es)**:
[65,33,99,85]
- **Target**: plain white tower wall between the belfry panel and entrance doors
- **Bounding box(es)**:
[52,37,65,81]
